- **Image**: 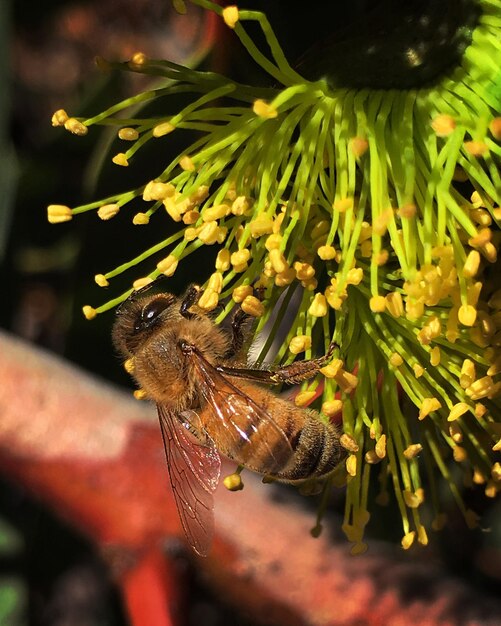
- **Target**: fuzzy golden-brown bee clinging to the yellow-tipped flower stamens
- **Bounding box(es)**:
[113,286,341,556]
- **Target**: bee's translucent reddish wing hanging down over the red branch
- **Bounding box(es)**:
[157,404,221,556]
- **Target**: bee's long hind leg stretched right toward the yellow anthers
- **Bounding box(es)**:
[216,342,338,385]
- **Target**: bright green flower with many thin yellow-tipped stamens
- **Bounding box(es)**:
[49,0,501,553]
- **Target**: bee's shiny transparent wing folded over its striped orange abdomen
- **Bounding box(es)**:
[191,349,293,475]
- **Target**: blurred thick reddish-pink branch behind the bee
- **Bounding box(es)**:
[0,334,501,626]
